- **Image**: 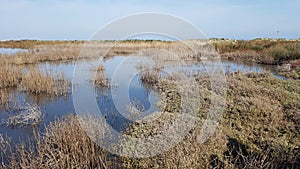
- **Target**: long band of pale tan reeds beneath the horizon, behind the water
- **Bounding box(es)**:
[0,41,216,65]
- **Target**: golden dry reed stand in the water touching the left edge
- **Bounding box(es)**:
[0,65,70,105]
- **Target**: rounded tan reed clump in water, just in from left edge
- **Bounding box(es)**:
[22,68,69,96]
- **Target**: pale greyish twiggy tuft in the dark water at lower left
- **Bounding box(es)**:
[5,104,42,126]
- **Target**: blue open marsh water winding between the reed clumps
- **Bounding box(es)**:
[0,56,285,143]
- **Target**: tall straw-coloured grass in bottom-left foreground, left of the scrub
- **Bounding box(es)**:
[0,115,115,169]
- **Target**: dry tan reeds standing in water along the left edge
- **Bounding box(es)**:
[0,66,70,110]
